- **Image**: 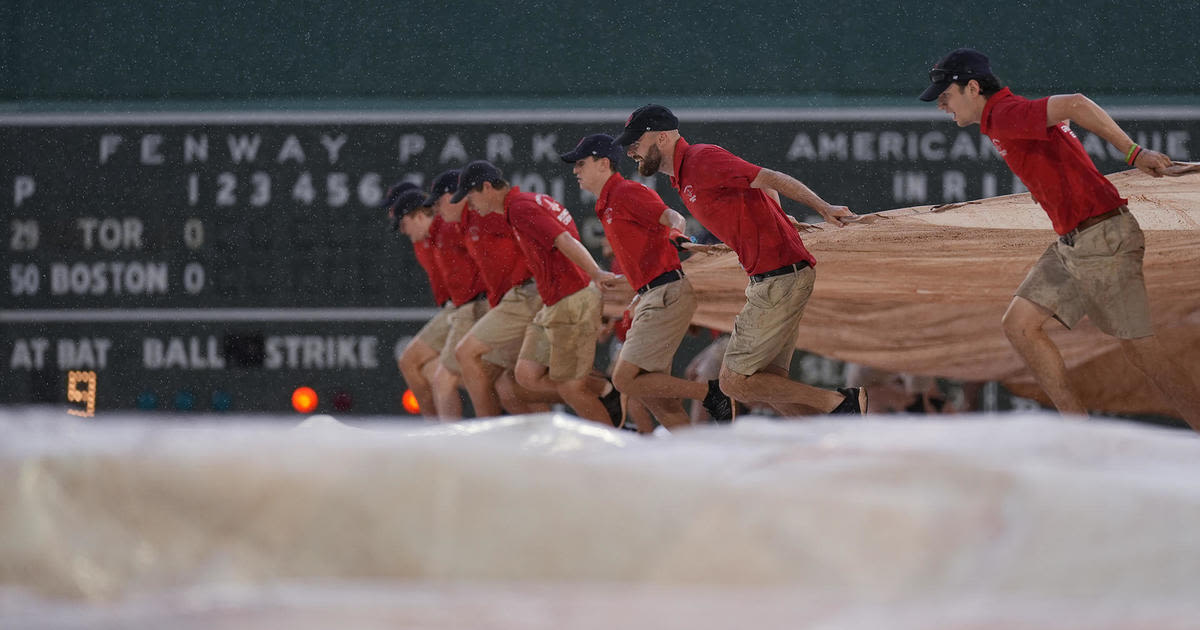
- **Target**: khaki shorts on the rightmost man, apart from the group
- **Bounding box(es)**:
[1016,212,1154,340]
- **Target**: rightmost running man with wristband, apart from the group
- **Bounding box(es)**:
[920,48,1200,431]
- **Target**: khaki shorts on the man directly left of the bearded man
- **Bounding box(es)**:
[620,278,696,372]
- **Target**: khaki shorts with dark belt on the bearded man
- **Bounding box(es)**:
[725,266,817,376]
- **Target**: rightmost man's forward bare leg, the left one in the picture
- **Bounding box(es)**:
[1002,295,1087,415]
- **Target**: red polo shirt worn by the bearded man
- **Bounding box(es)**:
[671,138,816,276]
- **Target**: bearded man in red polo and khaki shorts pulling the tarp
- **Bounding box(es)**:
[617,104,866,416]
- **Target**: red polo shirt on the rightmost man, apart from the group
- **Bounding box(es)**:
[979,88,1128,234]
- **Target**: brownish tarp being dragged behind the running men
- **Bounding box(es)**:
[606,164,1200,415]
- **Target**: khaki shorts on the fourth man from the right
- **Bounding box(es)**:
[520,284,600,383]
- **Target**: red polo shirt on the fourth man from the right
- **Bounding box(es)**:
[504,186,592,306]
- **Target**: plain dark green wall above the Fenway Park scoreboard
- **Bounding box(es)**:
[0,0,1200,109]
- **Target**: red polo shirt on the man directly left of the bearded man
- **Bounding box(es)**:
[596,173,680,289]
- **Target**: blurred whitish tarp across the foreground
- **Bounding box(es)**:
[0,410,1200,630]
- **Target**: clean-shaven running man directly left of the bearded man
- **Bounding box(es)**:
[559,133,733,430]
